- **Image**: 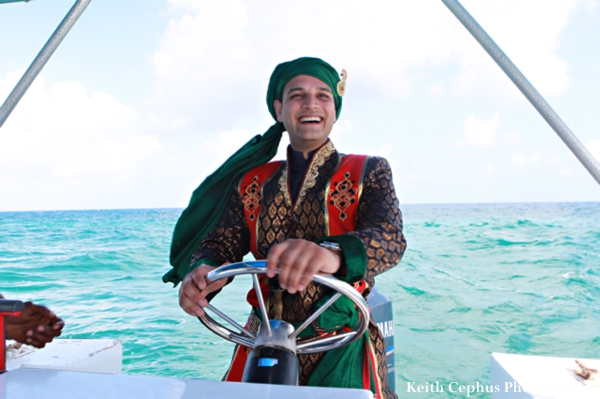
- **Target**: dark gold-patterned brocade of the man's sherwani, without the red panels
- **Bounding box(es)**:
[192,141,406,398]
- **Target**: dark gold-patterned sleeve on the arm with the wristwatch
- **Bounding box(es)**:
[348,157,406,284]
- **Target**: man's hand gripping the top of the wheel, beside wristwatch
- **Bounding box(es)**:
[267,239,341,294]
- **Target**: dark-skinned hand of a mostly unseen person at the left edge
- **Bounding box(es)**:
[5,302,65,348]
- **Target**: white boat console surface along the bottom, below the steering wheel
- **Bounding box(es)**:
[0,369,373,399]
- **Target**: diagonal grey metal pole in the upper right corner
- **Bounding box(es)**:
[442,0,600,184]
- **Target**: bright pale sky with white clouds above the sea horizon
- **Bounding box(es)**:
[0,0,600,211]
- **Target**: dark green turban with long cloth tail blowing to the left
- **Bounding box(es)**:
[163,57,344,285]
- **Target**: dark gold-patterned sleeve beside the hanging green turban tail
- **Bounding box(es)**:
[191,185,250,266]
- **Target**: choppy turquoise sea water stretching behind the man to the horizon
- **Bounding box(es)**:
[0,203,600,398]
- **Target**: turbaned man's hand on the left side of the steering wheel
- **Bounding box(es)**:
[179,262,229,317]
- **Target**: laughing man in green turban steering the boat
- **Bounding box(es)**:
[163,57,406,398]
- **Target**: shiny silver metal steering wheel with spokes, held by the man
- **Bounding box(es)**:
[199,261,370,354]
